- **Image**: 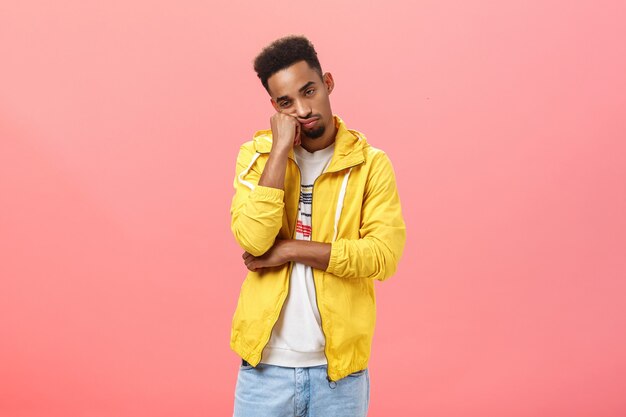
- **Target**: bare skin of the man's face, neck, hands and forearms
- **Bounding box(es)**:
[242,61,337,271]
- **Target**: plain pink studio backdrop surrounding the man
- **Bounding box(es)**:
[0,0,626,417]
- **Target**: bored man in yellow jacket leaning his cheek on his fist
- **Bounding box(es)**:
[230,36,405,417]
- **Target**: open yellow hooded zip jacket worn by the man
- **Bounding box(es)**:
[230,116,406,381]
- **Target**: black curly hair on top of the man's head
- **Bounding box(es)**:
[254,35,322,93]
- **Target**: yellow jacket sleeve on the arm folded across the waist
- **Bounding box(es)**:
[326,151,406,281]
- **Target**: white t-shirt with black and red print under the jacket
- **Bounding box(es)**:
[261,143,335,368]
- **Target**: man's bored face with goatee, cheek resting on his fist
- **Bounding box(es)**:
[267,61,334,139]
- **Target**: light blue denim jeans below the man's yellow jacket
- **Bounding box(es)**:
[233,363,370,417]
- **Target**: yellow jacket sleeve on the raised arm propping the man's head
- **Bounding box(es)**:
[230,145,285,256]
